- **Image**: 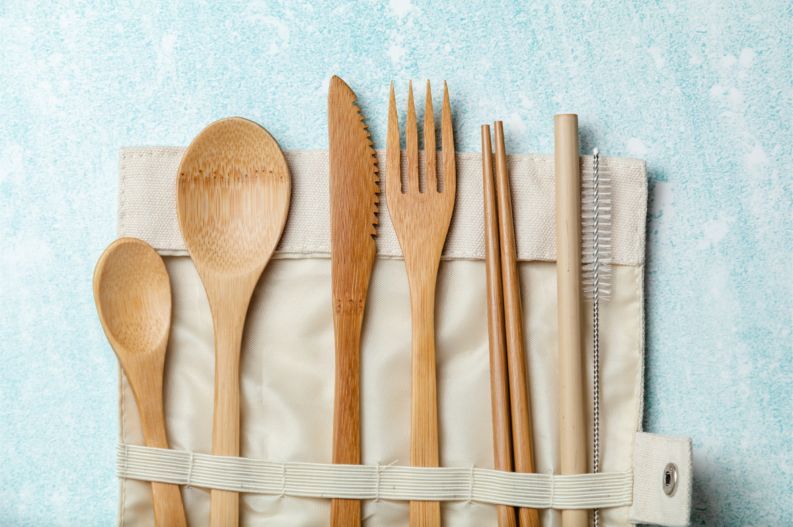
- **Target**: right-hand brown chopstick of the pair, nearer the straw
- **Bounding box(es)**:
[494,121,540,527]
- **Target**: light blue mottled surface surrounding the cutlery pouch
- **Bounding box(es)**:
[0,0,793,525]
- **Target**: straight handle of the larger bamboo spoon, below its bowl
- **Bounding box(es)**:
[209,310,247,527]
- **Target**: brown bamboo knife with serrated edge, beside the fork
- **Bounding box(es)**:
[328,76,380,527]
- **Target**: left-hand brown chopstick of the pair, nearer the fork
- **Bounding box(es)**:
[482,125,516,527]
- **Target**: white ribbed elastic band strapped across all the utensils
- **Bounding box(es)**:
[117,444,633,509]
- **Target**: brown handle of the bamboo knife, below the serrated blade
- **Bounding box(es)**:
[330,308,363,527]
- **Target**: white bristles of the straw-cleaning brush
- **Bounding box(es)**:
[581,149,612,300]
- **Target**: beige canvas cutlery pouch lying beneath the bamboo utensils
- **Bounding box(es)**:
[118,147,692,526]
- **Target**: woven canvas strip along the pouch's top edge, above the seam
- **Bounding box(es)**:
[118,147,647,265]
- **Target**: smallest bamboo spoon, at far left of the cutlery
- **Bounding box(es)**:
[94,238,187,526]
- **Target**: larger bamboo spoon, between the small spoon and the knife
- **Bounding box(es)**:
[176,117,291,527]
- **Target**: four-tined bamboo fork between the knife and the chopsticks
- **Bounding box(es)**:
[386,83,457,527]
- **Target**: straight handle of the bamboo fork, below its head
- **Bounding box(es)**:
[410,272,441,527]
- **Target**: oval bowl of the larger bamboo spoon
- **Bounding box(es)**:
[177,117,291,279]
